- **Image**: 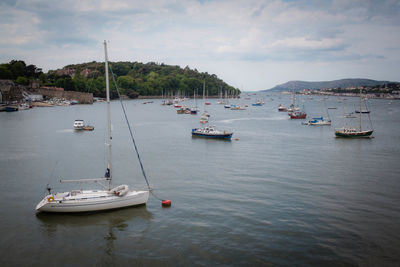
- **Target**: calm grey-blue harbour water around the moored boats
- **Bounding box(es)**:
[0,96,400,266]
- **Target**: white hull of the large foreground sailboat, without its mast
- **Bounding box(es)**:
[36,190,149,212]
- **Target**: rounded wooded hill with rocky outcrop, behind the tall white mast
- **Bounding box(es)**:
[55,62,238,97]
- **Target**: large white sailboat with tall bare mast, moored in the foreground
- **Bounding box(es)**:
[36,41,149,212]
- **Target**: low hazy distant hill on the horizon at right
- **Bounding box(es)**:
[263,79,396,92]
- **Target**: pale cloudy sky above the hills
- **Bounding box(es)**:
[0,0,400,91]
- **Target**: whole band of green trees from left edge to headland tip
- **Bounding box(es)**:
[0,60,240,98]
